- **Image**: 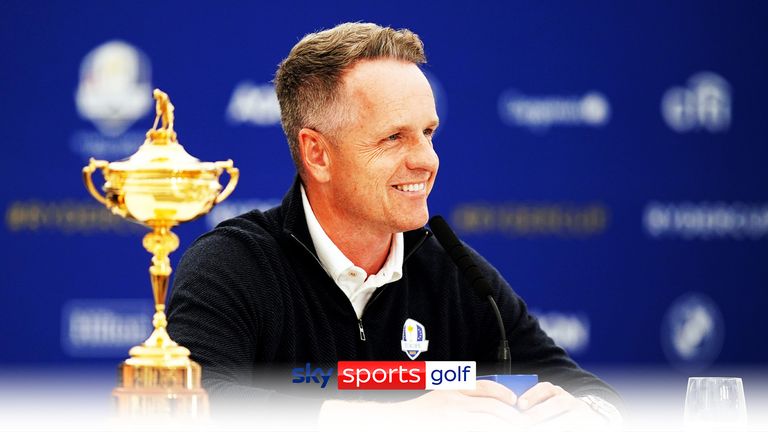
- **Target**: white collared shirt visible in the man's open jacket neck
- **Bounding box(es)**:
[301,185,404,319]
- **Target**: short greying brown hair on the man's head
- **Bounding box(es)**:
[274,23,427,177]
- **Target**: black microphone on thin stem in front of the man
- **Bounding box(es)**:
[429,216,512,375]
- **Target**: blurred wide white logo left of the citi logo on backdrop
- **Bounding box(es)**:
[498,89,611,131]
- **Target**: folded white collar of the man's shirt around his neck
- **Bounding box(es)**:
[301,185,404,284]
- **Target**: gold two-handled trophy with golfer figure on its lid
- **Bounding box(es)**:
[83,89,239,418]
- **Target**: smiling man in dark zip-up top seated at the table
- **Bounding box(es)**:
[169,23,619,421]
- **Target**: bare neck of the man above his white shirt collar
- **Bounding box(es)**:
[306,185,392,275]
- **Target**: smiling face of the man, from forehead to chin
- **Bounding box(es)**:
[329,59,439,233]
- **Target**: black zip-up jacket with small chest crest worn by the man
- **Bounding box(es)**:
[168,178,620,405]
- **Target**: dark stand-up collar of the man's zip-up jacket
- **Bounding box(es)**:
[280,175,432,264]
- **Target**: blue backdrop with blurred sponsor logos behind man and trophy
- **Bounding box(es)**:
[0,1,768,373]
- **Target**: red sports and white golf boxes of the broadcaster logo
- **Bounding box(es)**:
[338,361,477,390]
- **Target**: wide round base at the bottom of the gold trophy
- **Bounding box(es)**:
[112,358,209,420]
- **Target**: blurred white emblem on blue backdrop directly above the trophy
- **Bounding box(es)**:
[72,40,152,158]
